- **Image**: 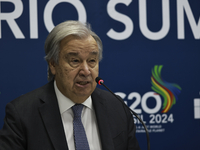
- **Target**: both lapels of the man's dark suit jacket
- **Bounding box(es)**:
[39,82,114,150]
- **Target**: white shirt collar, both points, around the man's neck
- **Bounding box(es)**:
[54,81,93,114]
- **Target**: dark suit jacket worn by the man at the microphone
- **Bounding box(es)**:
[0,82,140,150]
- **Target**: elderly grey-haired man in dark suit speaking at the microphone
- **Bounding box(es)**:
[0,21,140,150]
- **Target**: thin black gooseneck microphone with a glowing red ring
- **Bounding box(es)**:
[95,77,150,150]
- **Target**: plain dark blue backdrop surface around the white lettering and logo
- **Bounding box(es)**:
[0,0,200,150]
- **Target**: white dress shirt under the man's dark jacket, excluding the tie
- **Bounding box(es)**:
[54,81,102,150]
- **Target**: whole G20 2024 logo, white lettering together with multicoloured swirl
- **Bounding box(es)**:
[115,65,181,124]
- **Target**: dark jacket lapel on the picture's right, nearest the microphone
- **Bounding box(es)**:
[92,89,114,150]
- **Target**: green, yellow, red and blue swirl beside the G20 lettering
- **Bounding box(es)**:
[151,65,181,113]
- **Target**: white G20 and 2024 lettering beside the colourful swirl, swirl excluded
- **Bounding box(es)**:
[115,91,174,124]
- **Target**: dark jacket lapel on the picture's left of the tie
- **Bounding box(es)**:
[39,82,68,150]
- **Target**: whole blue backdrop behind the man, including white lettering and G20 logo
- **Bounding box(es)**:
[0,0,200,150]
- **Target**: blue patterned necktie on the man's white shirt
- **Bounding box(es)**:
[72,104,90,150]
